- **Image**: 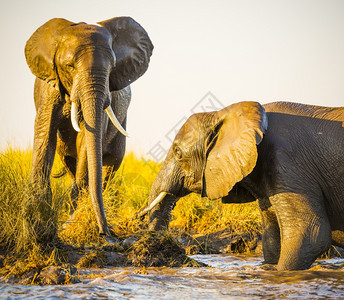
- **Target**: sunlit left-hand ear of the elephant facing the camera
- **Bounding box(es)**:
[25,18,74,89]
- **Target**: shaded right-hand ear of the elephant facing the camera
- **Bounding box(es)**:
[98,17,153,91]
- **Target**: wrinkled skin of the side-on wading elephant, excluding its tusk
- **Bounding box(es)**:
[149,102,344,270]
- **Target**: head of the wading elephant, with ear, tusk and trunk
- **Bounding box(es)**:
[139,102,267,230]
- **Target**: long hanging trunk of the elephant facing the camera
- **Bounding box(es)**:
[80,81,110,235]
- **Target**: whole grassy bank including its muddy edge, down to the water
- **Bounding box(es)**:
[0,147,260,284]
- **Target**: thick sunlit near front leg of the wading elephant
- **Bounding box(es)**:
[270,193,331,270]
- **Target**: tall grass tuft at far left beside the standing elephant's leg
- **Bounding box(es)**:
[0,147,66,254]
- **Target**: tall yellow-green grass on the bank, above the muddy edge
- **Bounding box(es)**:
[0,147,260,261]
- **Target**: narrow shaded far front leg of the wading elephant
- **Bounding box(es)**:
[259,199,281,265]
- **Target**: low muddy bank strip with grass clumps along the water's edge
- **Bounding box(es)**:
[0,230,261,285]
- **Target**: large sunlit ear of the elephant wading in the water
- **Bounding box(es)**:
[203,102,268,199]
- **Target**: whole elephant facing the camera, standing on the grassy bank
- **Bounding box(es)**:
[25,17,153,237]
